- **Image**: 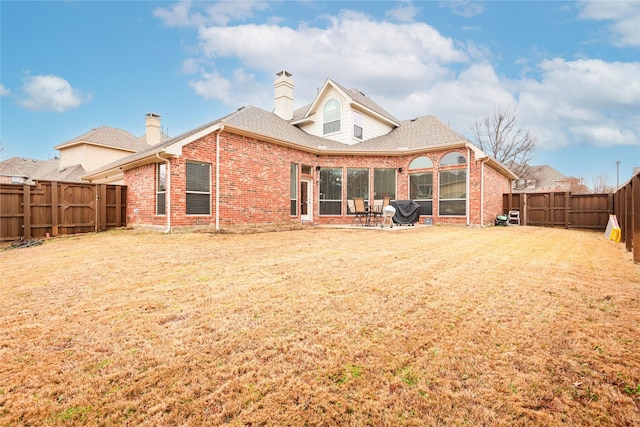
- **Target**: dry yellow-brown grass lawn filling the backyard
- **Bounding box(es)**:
[0,226,640,426]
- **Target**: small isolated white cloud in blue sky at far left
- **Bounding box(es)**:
[20,75,90,113]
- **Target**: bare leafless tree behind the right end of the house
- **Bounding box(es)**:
[471,106,538,175]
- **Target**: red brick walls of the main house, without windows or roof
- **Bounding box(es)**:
[125,132,508,228]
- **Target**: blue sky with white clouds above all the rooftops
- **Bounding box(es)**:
[0,0,640,186]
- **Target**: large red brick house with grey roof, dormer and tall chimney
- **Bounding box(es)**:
[83,71,517,231]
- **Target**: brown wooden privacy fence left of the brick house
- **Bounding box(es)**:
[0,181,127,241]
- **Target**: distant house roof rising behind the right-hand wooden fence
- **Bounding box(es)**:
[513,165,590,194]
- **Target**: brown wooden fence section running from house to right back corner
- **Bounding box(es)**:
[502,192,613,231]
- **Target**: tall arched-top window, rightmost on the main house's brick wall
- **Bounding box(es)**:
[438,151,467,216]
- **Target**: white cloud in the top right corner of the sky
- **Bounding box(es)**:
[579,0,640,46]
